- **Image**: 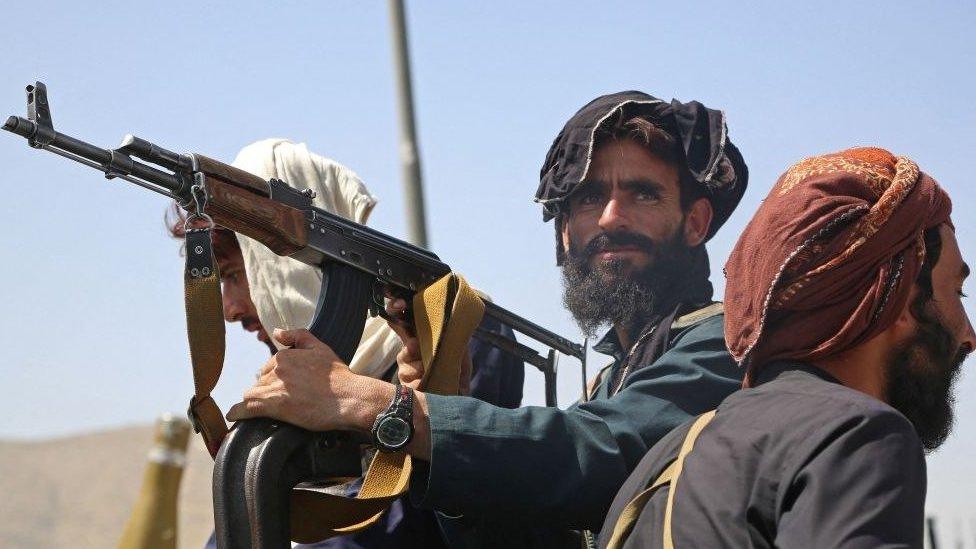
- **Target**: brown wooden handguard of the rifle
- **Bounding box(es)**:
[204,177,308,255]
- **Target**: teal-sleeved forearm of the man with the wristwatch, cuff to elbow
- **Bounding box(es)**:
[411,395,629,527]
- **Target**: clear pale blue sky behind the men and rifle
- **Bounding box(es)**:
[0,1,976,528]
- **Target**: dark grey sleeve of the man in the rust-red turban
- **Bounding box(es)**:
[775,409,926,548]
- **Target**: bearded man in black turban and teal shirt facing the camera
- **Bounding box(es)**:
[228,92,747,546]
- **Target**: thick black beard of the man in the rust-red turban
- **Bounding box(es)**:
[886,301,968,451]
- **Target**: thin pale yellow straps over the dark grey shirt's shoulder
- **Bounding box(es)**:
[607,410,715,549]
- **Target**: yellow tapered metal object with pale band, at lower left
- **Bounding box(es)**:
[119,414,190,549]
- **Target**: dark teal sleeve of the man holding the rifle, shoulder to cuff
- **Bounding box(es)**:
[411,317,741,529]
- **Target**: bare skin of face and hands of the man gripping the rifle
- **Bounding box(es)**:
[227,136,712,460]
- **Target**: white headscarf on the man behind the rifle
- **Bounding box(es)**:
[233,139,401,377]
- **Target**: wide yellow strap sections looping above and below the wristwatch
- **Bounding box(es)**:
[291,273,484,543]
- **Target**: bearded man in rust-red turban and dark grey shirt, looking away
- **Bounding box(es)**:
[601,148,976,547]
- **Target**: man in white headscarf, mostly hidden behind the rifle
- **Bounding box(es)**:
[174,139,525,549]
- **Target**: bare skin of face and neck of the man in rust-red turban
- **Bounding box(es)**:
[817,225,976,402]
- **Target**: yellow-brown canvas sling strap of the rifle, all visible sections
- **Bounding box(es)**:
[184,223,485,543]
